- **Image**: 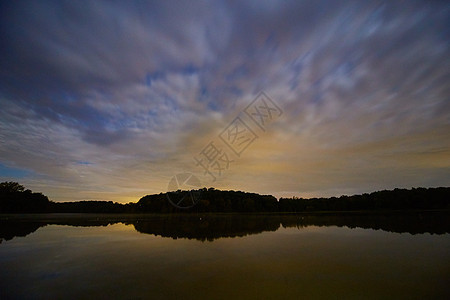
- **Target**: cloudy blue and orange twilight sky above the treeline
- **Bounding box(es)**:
[0,0,450,202]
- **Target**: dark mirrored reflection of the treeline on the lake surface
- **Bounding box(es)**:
[0,212,450,243]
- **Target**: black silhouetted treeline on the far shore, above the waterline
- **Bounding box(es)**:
[0,182,450,213]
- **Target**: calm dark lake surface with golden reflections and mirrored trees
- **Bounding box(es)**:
[0,213,450,299]
